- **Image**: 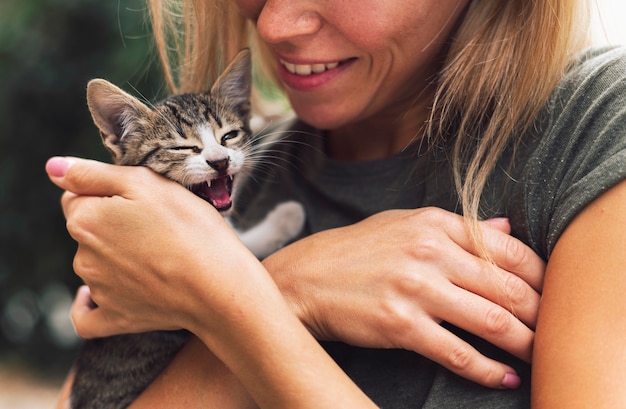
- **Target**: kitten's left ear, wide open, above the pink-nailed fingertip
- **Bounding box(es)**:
[87,79,151,162]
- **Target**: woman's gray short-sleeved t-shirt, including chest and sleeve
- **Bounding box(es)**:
[237,49,626,409]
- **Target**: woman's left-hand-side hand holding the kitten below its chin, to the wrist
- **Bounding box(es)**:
[47,158,253,338]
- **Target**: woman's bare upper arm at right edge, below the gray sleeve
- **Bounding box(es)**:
[532,181,626,408]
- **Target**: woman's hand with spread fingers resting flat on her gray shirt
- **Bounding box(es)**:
[264,208,545,387]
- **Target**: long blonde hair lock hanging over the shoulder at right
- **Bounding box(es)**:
[429,0,590,252]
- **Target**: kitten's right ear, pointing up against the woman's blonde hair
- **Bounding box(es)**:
[211,49,252,118]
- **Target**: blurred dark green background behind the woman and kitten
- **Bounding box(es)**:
[0,0,626,409]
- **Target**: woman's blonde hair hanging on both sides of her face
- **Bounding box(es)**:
[149,0,588,245]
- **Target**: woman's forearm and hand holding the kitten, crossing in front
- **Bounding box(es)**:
[47,159,375,408]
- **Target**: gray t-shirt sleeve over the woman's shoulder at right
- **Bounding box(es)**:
[522,48,626,259]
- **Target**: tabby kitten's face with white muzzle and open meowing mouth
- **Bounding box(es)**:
[116,94,250,211]
